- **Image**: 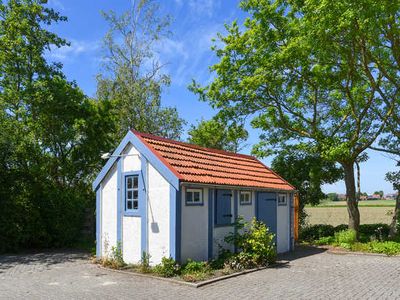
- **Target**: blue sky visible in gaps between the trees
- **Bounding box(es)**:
[48,0,395,193]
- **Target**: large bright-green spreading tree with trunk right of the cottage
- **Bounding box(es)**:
[191,0,400,231]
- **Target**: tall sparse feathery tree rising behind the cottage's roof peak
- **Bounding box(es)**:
[97,0,185,143]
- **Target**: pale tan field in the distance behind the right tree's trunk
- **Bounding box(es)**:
[305,200,395,226]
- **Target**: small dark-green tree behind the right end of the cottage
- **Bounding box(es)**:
[271,147,343,224]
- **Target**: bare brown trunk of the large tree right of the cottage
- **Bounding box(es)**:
[342,162,360,238]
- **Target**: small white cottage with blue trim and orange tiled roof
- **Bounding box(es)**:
[93,130,295,265]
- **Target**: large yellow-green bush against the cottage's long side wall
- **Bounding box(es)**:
[224,218,276,269]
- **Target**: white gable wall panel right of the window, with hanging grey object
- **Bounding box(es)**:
[147,164,170,264]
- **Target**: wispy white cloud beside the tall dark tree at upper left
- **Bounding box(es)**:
[49,40,100,62]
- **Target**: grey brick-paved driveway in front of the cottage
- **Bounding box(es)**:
[0,249,400,300]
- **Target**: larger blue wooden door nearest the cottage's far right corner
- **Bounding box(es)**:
[256,192,277,237]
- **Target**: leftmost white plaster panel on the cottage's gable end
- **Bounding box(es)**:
[100,164,117,257]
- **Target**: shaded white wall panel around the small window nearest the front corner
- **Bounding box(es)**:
[181,187,209,262]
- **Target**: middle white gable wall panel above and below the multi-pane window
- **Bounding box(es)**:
[120,144,142,263]
